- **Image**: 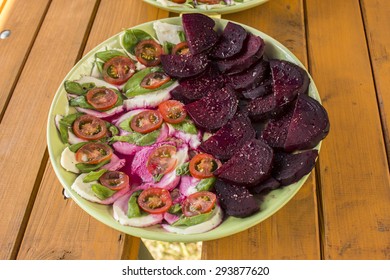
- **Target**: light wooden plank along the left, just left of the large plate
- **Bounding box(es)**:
[0,0,96,259]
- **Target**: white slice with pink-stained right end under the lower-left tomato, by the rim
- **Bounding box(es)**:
[71,173,130,204]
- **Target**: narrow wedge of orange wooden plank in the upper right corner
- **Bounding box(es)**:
[361,0,390,161]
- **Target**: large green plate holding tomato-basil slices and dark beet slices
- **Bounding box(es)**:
[47,13,329,242]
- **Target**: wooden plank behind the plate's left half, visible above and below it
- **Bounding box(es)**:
[18,0,169,259]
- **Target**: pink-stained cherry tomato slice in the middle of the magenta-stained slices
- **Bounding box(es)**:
[146,145,177,176]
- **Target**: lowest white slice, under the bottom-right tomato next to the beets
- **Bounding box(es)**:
[162,205,223,234]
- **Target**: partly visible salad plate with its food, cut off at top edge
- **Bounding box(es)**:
[144,0,268,15]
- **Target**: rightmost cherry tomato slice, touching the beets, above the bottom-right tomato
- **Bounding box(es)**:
[190,154,222,179]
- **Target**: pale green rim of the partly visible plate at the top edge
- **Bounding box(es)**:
[144,0,268,15]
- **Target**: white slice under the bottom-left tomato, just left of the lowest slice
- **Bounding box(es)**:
[113,192,163,227]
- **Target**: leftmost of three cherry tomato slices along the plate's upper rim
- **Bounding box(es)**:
[103,56,136,85]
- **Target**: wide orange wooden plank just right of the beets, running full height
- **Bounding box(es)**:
[306,0,390,259]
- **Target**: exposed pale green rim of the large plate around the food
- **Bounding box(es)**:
[47,17,320,242]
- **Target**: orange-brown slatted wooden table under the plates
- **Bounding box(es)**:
[0,0,390,259]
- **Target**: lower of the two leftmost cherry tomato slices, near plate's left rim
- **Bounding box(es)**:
[76,142,112,164]
